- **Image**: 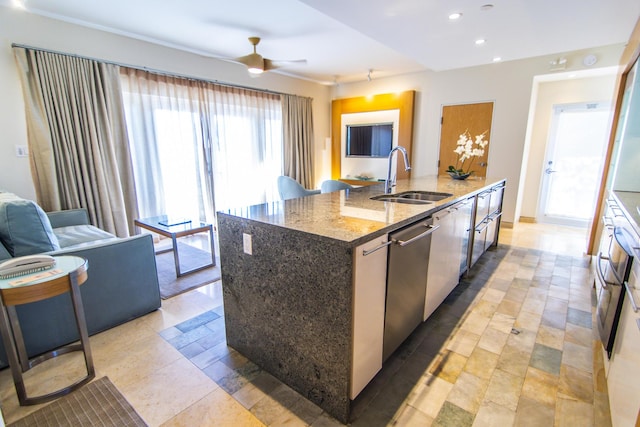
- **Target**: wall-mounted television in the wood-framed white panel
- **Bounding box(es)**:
[346,123,393,157]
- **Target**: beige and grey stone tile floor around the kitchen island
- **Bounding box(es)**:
[0,223,610,427]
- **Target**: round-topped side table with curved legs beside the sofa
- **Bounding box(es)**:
[0,256,95,405]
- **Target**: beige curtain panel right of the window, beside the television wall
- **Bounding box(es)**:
[282,95,315,188]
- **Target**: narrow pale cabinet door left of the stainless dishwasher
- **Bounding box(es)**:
[349,235,388,399]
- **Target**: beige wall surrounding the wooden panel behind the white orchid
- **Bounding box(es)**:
[332,45,624,223]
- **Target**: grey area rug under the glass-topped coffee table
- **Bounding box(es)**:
[156,242,220,299]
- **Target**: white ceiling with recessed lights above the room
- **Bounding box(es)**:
[5,0,640,82]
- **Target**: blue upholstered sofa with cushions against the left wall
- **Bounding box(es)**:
[0,192,160,367]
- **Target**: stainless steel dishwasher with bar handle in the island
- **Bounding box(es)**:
[382,218,438,360]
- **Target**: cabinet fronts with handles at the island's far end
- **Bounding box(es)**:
[469,183,504,267]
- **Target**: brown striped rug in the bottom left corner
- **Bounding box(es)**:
[8,377,147,427]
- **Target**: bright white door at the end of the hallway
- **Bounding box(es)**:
[537,102,611,227]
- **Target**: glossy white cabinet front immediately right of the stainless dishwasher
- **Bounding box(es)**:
[423,198,473,320]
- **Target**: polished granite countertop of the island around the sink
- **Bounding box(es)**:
[219,176,504,246]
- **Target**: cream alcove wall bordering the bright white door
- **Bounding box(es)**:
[520,74,616,218]
